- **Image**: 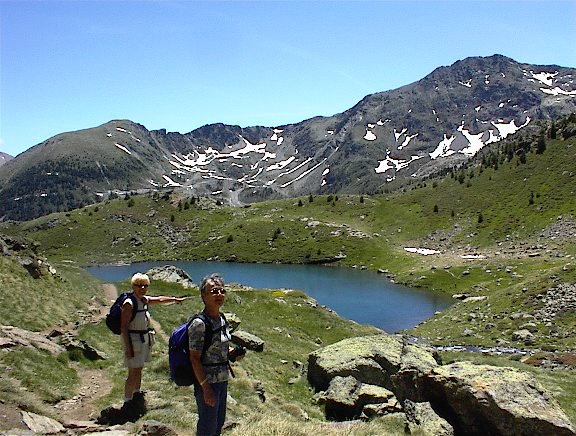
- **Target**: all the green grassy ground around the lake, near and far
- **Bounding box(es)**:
[0,115,576,435]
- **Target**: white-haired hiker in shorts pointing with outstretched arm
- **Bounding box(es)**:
[120,273,186,412]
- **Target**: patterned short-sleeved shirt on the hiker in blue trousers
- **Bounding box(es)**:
[188,314,232,383]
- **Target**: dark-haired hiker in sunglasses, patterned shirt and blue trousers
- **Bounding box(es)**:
[188,274,242,436]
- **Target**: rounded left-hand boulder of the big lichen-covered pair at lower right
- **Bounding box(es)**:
[308,334,438,391]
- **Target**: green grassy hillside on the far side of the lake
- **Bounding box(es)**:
[6,117,576,348]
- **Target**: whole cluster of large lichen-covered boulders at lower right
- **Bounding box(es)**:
[308,334,576,436]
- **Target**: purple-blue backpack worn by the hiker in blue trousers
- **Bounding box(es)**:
[168,313,228,386]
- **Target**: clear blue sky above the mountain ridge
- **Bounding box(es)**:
[0,0,576,156]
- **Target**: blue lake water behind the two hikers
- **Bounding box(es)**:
[86,261,453,333]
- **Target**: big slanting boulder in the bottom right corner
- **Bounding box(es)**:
[419,362,575,436]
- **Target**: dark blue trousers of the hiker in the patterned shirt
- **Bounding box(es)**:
[194,382,228,436]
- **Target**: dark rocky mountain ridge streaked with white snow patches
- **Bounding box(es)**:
[0,55,576,219]
